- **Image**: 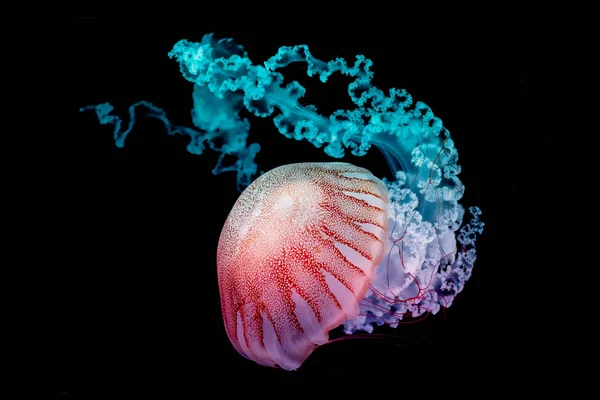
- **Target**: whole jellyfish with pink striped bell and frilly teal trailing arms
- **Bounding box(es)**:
[81,34,484,370]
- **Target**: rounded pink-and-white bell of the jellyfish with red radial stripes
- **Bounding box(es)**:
[217,163,388,370]
